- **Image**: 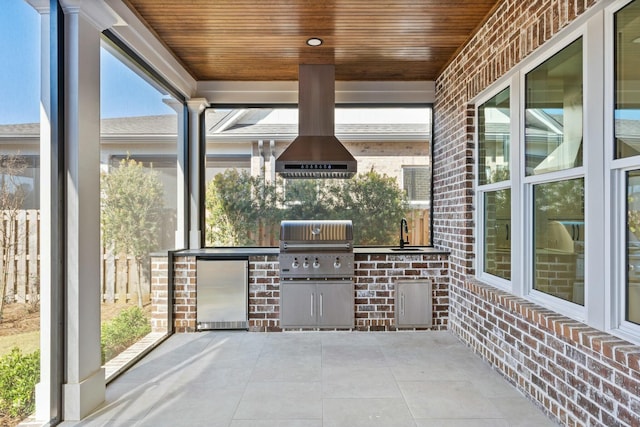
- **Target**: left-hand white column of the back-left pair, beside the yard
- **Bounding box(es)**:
[163,98,189,249]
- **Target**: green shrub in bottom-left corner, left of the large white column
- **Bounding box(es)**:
[0,347,40,418]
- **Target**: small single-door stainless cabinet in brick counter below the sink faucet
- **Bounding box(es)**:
[396,279,433,328]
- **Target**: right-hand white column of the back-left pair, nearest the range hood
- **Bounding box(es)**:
[187,98,209,249]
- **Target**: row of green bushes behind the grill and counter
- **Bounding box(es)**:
[205,170,407,246]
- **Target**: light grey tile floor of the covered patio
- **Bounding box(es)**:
[61,331,557,427]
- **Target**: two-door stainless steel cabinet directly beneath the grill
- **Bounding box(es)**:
[280,281,354,328]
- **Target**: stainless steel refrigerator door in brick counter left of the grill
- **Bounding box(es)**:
[196,259,249,329]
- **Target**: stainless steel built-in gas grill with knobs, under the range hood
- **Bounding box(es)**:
[279,220,353,280]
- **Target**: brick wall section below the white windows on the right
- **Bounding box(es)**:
[450,281,640,427]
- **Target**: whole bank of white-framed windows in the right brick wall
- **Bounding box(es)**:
[476,0,640,342]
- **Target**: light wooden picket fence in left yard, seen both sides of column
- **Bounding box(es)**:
[0,210,150,303]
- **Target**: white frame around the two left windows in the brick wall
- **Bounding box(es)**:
[474,5,608,330]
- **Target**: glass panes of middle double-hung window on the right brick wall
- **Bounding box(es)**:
[524,38,585,305]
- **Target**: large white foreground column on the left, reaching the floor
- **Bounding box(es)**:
[61,0,116,420]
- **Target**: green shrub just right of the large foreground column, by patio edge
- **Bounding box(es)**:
[101,307,151,363]
